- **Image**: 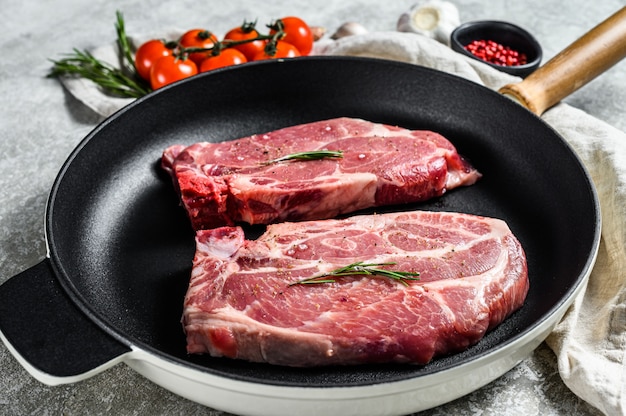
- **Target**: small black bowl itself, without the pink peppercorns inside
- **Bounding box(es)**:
[450,20,543,78]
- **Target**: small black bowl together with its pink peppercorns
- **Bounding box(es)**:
[450,20,543,78]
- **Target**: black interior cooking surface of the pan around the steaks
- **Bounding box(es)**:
[46,58,599,387]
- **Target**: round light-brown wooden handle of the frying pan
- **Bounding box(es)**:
[500,7,626,116]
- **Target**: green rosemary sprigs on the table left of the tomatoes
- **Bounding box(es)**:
[48,12,151,98]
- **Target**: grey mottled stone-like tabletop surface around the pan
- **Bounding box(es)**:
[0,0,626,415]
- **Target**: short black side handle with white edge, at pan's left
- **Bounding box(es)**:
[0,258,131,385]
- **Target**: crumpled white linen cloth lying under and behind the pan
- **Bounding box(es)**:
[62,32,626,415]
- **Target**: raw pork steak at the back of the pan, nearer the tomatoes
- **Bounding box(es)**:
[162,118,480,230]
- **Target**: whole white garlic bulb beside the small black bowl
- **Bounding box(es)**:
[397,0,461,45]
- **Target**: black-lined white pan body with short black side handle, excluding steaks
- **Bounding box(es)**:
[0,7,620,415]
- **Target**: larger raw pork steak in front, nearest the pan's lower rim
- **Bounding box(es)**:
[183,212,529,366]
